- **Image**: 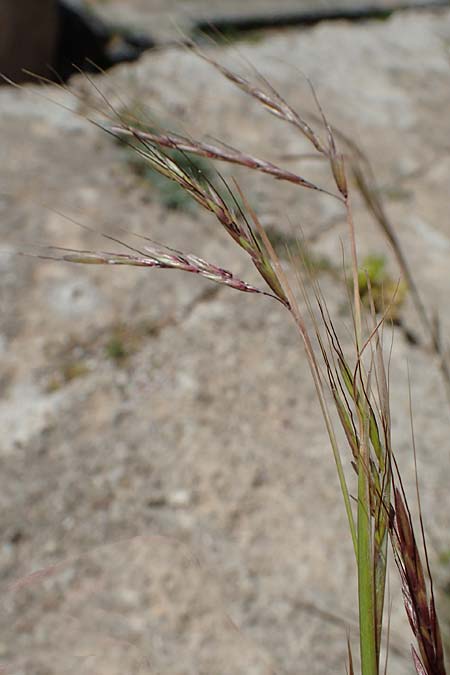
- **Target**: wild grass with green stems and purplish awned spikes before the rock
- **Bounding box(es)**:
[14,47,448,675]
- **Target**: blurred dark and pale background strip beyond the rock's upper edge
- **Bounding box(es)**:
[0,0,447,82]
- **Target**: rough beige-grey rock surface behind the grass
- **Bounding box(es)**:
[0,6,450,675]
